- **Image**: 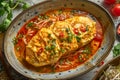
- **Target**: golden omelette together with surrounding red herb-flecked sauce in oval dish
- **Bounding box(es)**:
[13,8,103,73]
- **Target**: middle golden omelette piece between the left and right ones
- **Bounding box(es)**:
[50,21,78,55]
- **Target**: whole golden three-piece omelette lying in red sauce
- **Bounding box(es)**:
[26,16,96,67]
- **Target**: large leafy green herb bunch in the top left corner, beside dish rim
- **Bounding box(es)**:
[0,0,30,32]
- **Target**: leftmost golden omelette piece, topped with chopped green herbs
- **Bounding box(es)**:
[26,28,62,67]
